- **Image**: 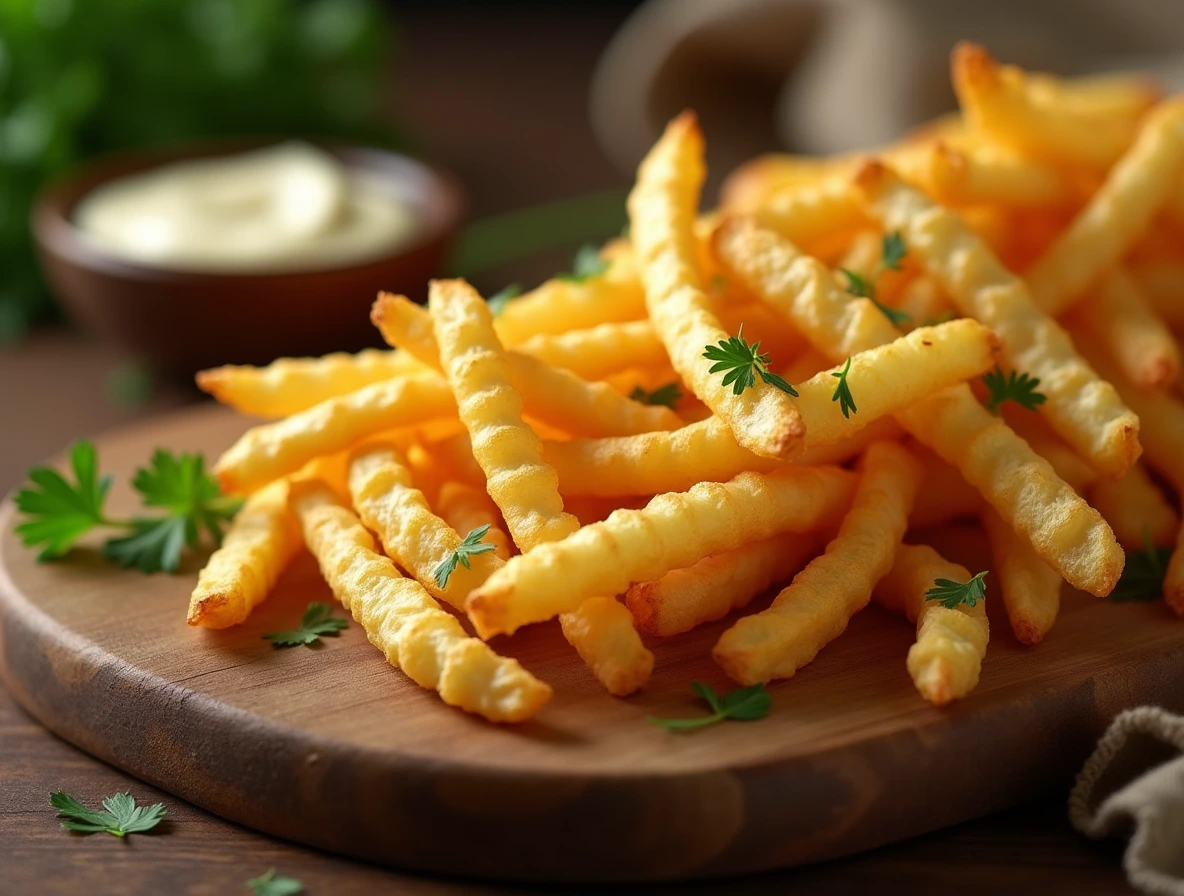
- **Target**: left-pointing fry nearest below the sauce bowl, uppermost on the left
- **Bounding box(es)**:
[197,348,426,418]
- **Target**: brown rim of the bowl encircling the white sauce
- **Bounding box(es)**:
[30,135,468,284]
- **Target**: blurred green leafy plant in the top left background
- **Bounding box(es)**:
[0,0,397,343]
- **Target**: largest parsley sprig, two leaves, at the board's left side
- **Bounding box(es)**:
[17,439,243,573]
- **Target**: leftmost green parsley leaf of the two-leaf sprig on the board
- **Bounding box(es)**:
[17,439,111,560]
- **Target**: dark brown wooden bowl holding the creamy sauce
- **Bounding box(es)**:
[32,141,465,376]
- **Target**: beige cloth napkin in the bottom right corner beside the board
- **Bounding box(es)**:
[1069,707,1184,896]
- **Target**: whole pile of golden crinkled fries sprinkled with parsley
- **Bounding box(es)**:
[189,44,1184,722]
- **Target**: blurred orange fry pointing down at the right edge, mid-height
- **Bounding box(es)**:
[1070,267,1182,389]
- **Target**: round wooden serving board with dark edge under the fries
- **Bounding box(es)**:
[0,407,1184,881]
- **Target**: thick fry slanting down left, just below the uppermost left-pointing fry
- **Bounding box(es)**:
[214,373,456,495]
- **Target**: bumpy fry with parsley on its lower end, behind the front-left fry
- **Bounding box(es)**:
[349,445,501,610]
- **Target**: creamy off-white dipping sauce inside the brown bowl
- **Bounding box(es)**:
[73,142,418,273]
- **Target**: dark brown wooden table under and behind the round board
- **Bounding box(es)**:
[0,7,1128,896]
